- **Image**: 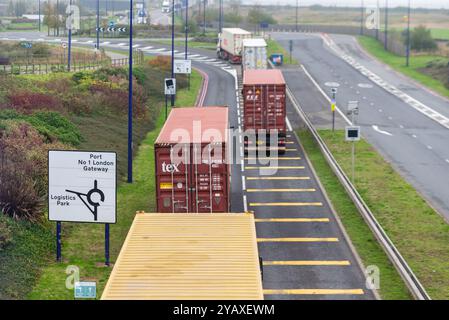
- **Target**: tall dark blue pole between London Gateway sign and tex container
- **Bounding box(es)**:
[128,0,134,183]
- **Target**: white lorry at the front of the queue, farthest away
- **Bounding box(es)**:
[217,28,252,64]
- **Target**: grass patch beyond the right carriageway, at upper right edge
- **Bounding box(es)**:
[358,37,449,97]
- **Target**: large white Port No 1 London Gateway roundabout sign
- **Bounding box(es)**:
[48,151,117,223]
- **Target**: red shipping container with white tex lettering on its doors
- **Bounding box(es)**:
[154,107,231,213]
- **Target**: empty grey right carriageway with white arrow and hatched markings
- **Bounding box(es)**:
[273,33,449,221]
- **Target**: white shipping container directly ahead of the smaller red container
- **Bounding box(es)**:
[242,39,268,70]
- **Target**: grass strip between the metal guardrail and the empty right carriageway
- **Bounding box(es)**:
[300,130,449,300]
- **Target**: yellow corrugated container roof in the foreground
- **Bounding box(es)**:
[102,213,263,300]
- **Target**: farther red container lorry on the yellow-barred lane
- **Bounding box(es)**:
[242,69,287,153]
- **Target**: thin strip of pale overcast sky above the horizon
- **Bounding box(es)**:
[243,0,449,9]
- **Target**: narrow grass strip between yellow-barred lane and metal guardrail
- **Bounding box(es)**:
[298,131,412,300]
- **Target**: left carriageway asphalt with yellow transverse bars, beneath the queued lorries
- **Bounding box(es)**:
[0,31,374,300]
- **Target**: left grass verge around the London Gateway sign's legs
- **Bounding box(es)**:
[28,71,201,300]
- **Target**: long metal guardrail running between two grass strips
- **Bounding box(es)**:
[287,87,431,300]
